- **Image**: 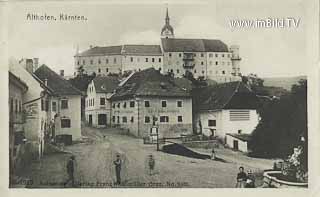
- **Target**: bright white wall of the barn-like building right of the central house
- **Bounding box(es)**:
[194,110,259,138]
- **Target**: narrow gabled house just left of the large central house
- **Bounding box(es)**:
[85,76,120,127]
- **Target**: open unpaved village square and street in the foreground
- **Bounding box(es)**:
[15,127,272,188]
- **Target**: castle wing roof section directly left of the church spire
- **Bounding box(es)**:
[122,45,162,55]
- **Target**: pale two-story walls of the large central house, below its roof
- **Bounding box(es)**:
[112,97,192,137]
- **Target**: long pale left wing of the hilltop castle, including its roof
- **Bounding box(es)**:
[74,45,163,75]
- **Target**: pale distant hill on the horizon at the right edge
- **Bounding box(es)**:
[263,76,307,91]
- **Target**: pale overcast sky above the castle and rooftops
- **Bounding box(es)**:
[8,0,308,77]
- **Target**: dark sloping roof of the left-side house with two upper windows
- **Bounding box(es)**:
[34,65,81,95]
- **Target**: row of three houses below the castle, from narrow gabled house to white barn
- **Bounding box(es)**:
[85,68,259,151]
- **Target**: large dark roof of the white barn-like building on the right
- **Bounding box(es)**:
[192,82,259,110]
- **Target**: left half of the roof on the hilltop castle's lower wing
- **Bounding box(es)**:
[76,45,122,56]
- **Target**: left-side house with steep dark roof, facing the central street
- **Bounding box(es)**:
[34,65,82,140]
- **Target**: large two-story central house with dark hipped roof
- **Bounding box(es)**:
[111,68,192,137]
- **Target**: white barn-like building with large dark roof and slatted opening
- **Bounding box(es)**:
[193,82,259,150]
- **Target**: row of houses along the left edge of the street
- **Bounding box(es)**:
[8,59,82,174]
